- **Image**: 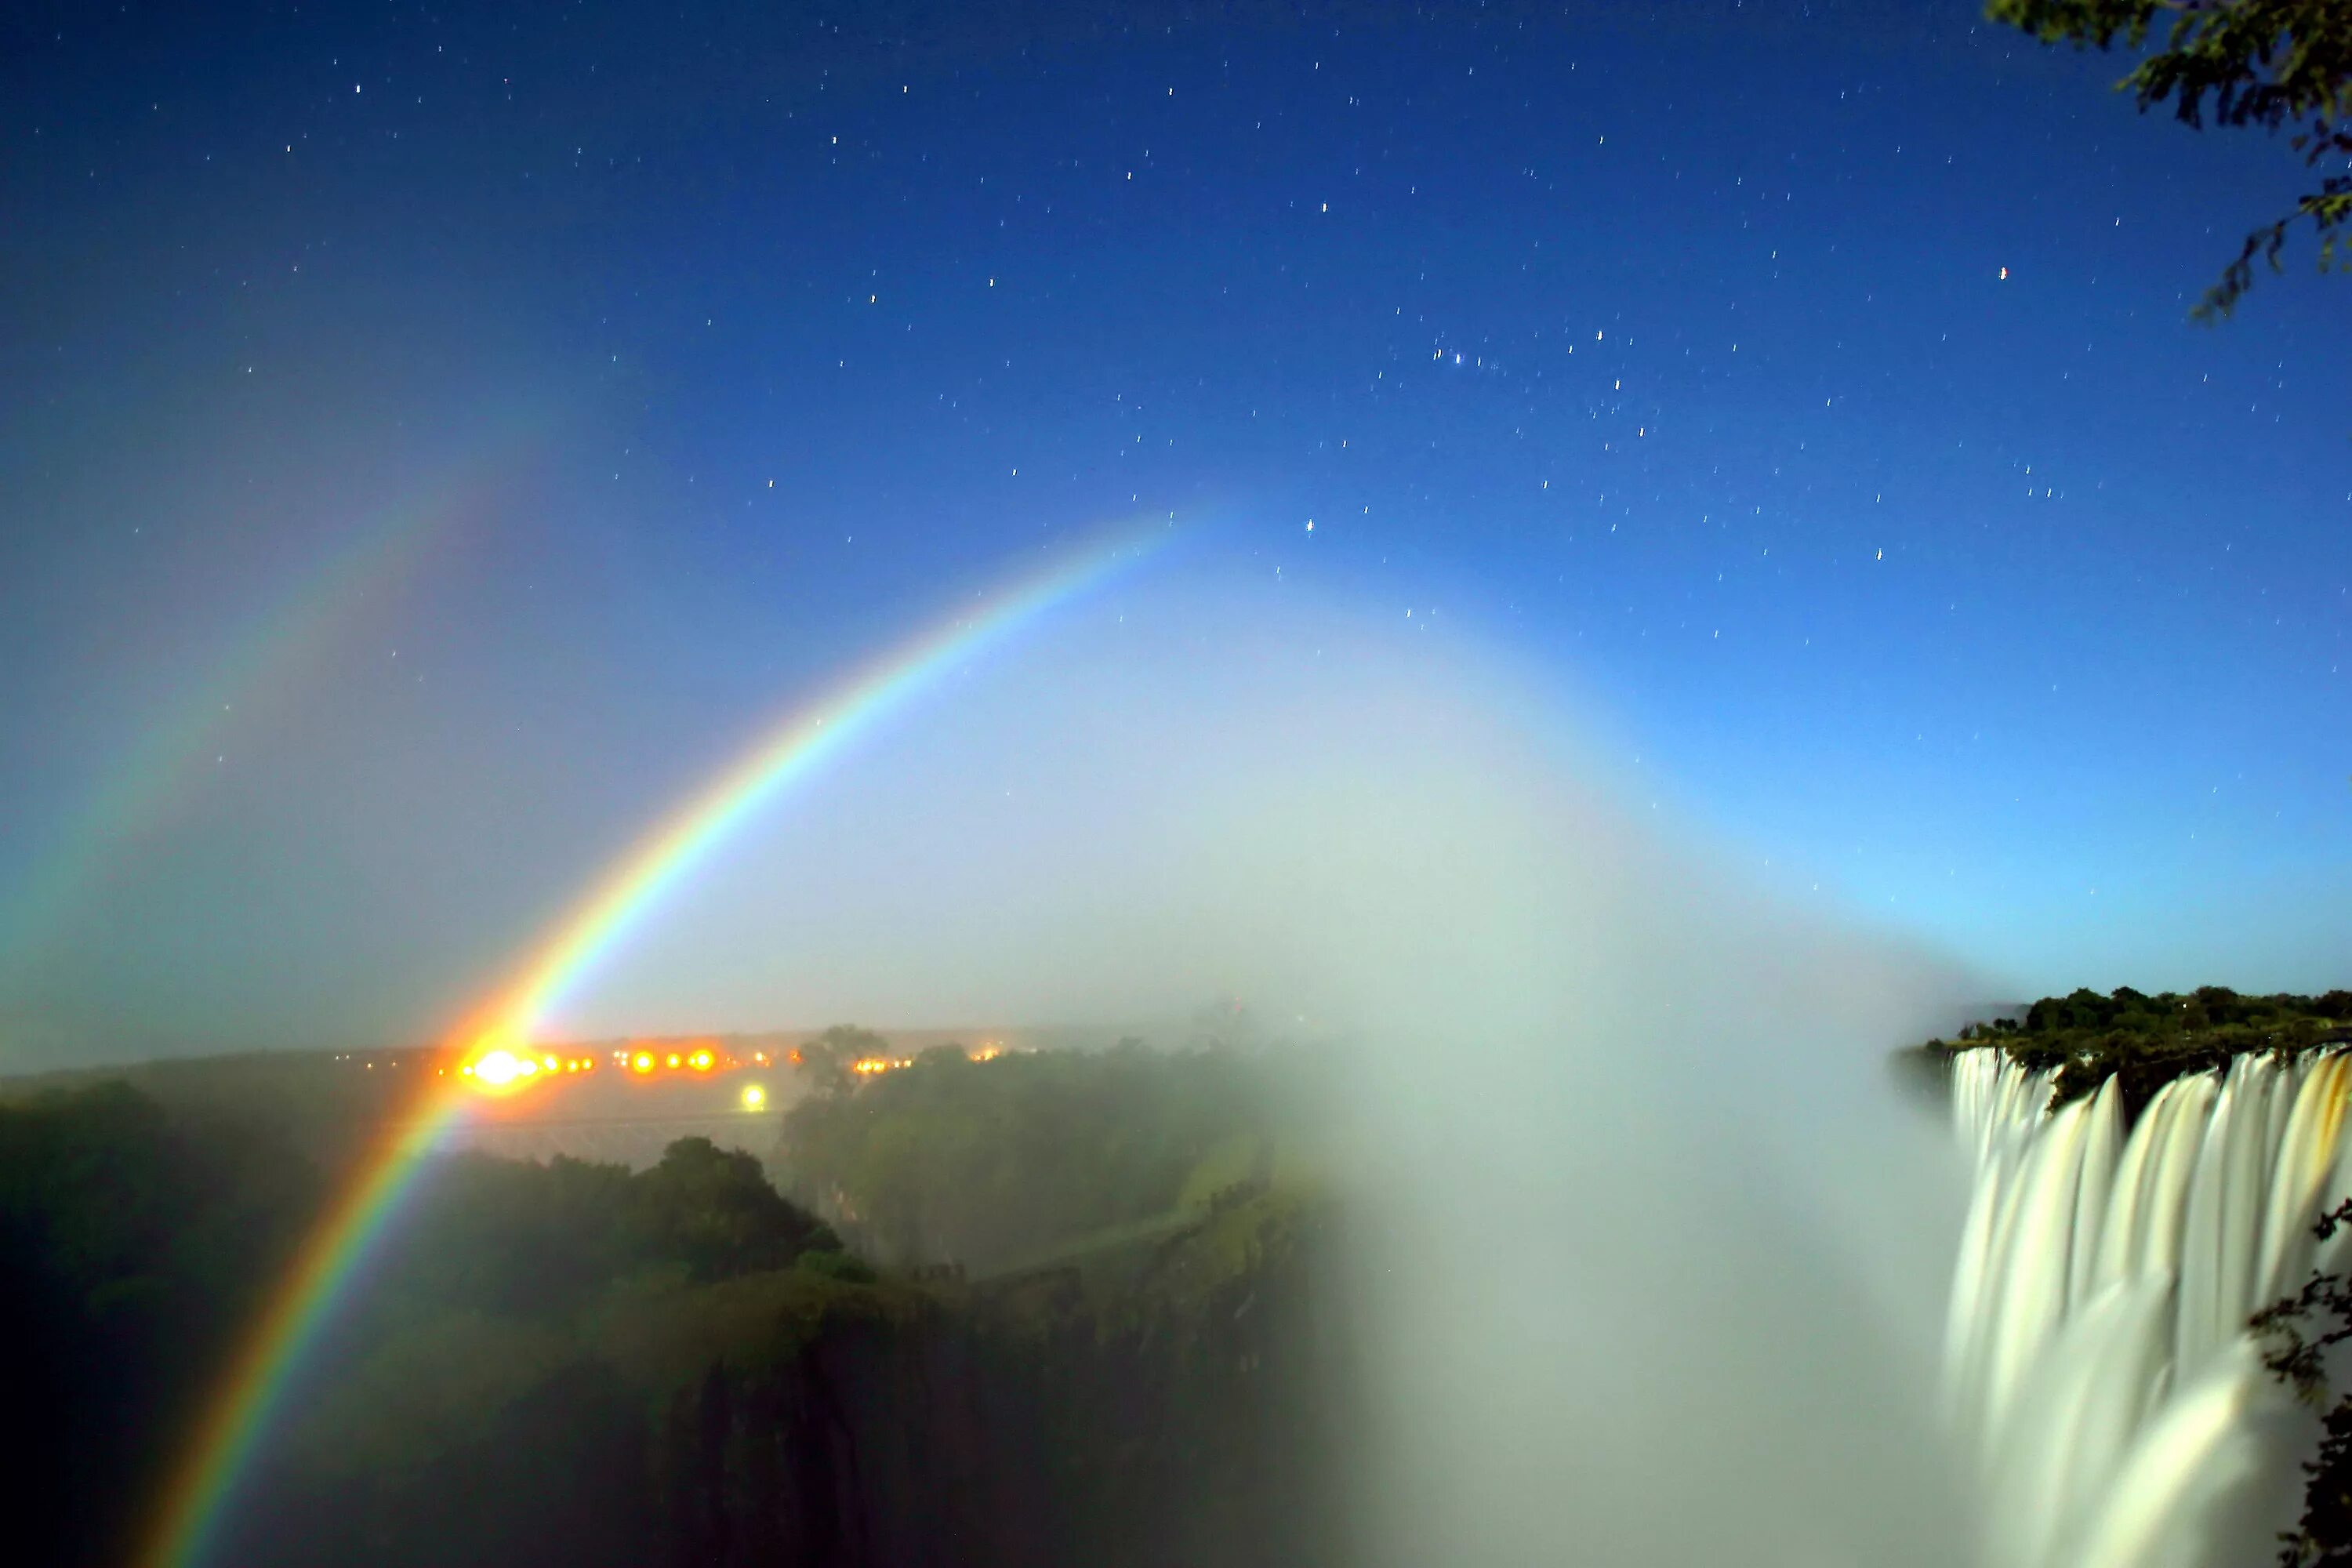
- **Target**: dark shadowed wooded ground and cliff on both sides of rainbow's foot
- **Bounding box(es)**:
[0,1046,1357,1568]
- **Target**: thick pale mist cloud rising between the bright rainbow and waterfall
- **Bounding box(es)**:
[567,564,1985,1563]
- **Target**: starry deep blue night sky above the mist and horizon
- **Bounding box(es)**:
[0,0,2352,1065]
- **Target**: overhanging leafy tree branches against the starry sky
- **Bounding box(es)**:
[1985,0,2352,322]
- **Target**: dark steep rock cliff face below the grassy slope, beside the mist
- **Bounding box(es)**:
[654,1203,1350,1568]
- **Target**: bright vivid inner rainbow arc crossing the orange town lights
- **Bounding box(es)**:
[136,534,1164,1568]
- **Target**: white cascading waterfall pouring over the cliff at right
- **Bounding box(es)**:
[1945,1048,2352,1568]
